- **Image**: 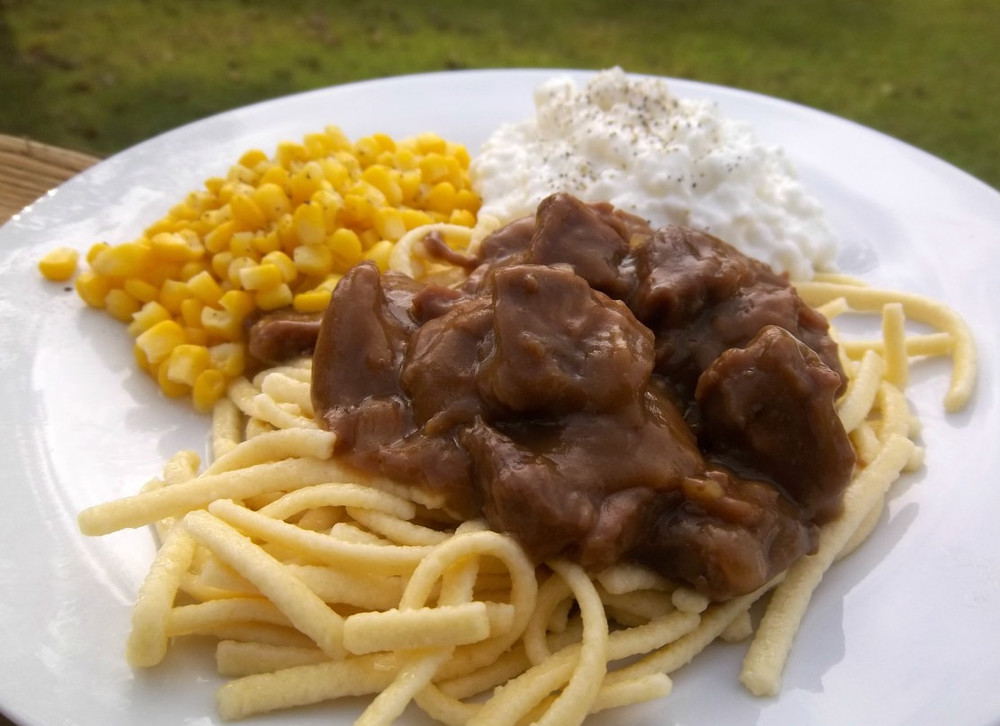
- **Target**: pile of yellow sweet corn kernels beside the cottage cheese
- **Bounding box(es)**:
[48,127,480,411]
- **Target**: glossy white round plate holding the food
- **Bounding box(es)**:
[0,70,1000,726]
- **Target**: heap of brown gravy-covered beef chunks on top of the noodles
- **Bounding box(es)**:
[313,195,854,599]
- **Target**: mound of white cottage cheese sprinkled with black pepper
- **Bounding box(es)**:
[470,68,837,279]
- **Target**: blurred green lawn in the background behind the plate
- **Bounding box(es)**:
[0,0,1000,188]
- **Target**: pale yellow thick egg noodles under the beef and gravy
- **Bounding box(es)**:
[79,226,976,726]
